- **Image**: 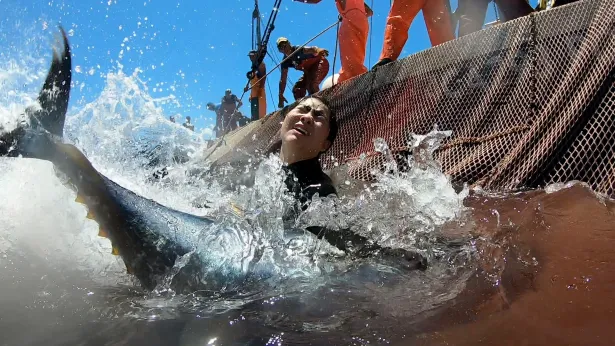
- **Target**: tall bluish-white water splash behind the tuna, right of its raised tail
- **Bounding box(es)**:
[66,69,211,175]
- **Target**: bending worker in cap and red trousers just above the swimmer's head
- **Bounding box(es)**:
[277,37,329,108]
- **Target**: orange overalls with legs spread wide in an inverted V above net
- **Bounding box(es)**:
[380,0,455,60]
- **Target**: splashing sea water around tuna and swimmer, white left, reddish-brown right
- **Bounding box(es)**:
[0,23,615,345]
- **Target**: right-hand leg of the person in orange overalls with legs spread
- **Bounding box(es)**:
[423,0,458,46]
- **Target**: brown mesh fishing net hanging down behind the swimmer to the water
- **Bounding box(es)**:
[205,0,615,195]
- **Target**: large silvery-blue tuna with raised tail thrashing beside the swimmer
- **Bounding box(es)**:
[0,28,434,293]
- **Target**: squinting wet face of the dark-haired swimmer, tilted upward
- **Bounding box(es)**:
[280,98,331,163]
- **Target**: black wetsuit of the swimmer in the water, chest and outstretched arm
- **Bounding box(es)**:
[284,158,426,269]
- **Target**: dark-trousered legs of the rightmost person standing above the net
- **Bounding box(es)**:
[455,0,534,37]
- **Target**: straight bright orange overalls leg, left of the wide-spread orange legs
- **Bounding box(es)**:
[334,0,369,83]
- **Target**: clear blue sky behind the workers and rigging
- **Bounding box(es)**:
[0,0,535,133]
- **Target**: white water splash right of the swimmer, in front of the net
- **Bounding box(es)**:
[302,128,469,258]
